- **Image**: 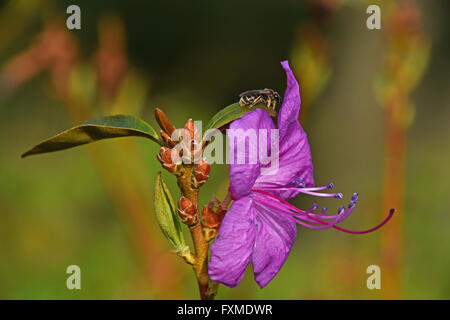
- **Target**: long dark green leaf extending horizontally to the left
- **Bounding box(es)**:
[22,115,163,158]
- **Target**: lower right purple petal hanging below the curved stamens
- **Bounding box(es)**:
[252,194,297,288]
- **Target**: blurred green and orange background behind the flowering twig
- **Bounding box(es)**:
[0,0,450,299]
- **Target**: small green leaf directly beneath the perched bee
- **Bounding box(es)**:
[203,103,276,140]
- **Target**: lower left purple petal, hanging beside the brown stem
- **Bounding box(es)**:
[208,197,256,287]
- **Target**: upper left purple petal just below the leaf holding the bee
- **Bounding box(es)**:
[227,109,275,199]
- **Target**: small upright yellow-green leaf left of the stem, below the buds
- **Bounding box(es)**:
[154,172,187,251]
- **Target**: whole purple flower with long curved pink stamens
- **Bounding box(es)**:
[209,61,393,288]
